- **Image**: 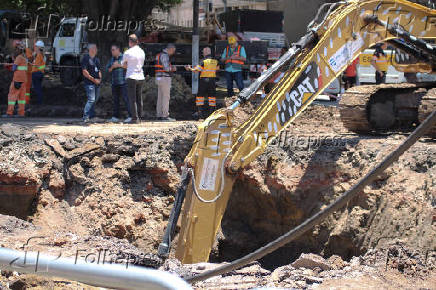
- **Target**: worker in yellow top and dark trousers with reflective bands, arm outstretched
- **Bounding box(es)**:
[186,47,219,120]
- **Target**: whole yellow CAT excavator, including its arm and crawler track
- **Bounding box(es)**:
[158,0,436,264]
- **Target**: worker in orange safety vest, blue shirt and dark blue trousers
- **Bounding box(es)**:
[221,36,247,98]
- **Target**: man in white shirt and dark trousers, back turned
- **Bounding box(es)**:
[123,34,145,123]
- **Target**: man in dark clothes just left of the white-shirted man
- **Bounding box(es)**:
[106,44,132,123]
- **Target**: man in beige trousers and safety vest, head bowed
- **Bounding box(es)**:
[154,43,177,122]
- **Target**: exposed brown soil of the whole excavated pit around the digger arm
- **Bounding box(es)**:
[0,99,436,289]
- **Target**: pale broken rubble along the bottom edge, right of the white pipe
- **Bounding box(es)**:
[160,242,436,289]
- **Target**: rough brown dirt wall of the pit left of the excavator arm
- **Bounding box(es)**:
[0,124,195,252]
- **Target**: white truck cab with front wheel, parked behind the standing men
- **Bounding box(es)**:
[53,17,88,86]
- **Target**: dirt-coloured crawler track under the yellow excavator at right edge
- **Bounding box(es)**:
[340,84,436,137]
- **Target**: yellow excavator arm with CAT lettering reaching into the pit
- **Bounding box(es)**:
[159,0,436,263]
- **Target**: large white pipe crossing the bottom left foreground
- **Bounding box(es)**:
[0,247,192,290]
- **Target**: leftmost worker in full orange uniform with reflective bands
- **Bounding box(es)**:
[3,43,28,117]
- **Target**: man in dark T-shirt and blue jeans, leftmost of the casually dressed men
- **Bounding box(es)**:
[82,43,101,123]
